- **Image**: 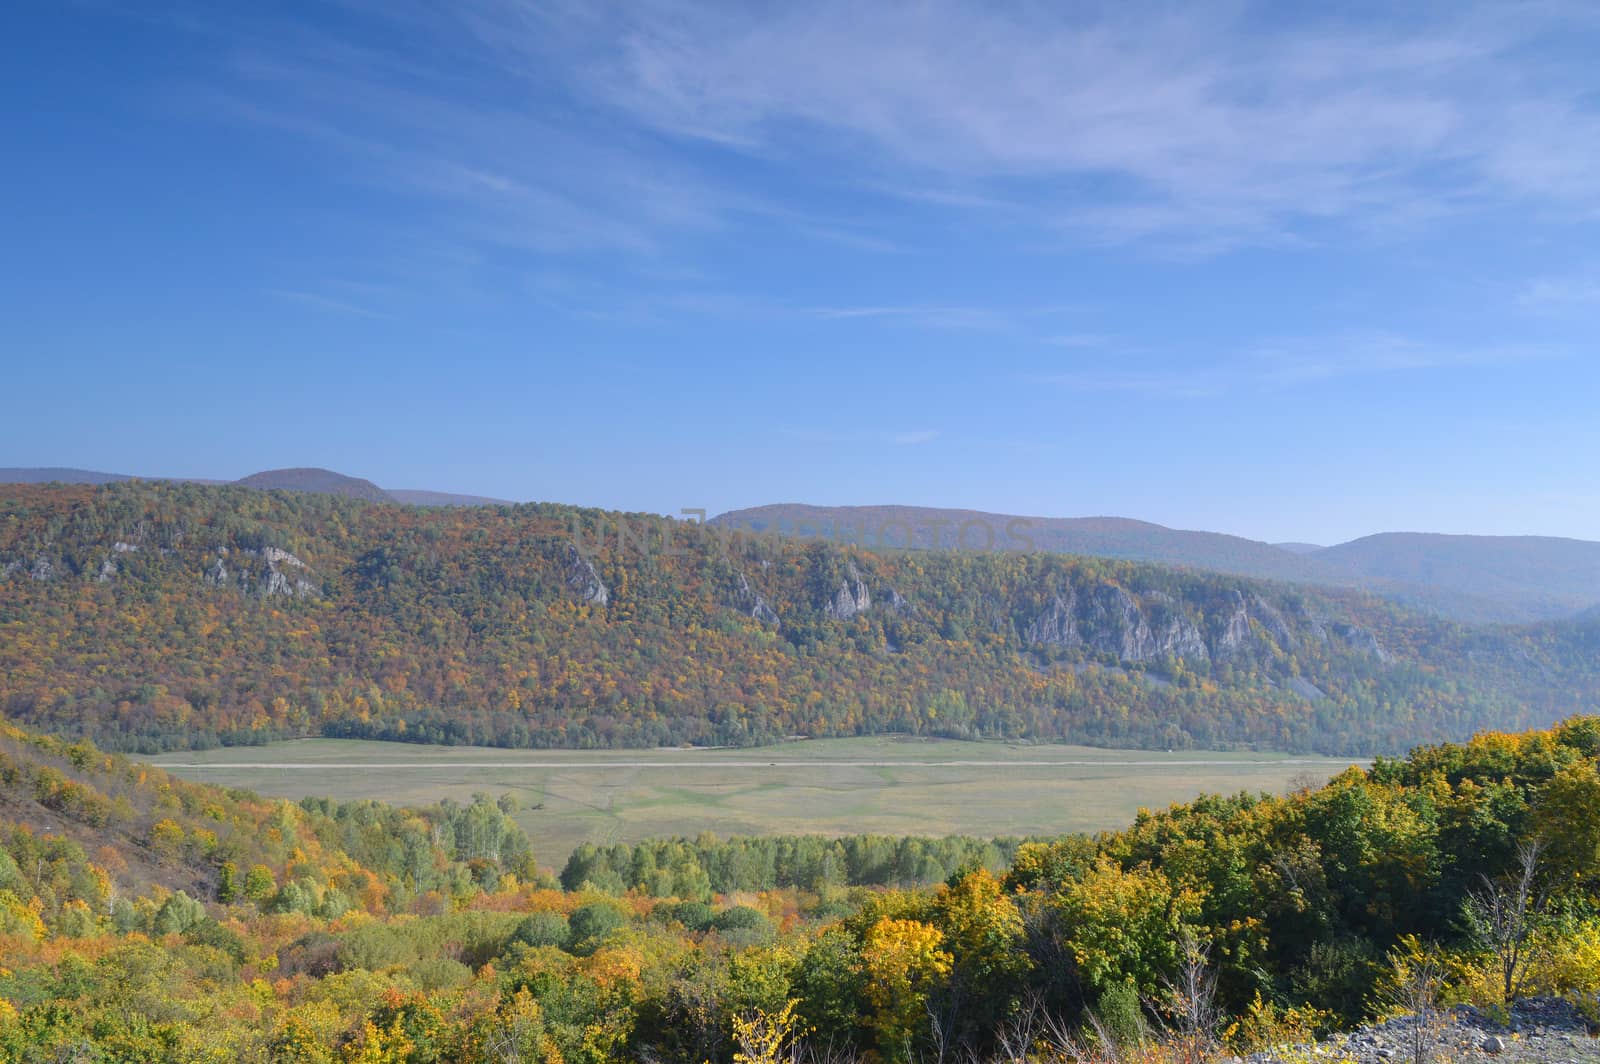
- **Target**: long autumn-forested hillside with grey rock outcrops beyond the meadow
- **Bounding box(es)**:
[0,483,1600,754]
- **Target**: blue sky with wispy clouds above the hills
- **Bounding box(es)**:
[0,0,1600,542]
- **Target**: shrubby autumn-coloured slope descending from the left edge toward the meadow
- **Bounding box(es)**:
[0,720,533,930]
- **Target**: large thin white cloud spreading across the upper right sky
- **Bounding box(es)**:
[515,0,1600,240]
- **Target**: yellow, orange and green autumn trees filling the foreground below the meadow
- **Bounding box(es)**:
[0,717,1600,1064]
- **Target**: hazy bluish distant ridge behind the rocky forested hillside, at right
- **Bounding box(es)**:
[710,504,1600,624]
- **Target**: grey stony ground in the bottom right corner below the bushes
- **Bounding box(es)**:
[1246,998,1600,1064]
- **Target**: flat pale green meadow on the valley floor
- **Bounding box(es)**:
[150,736,1352,867]
